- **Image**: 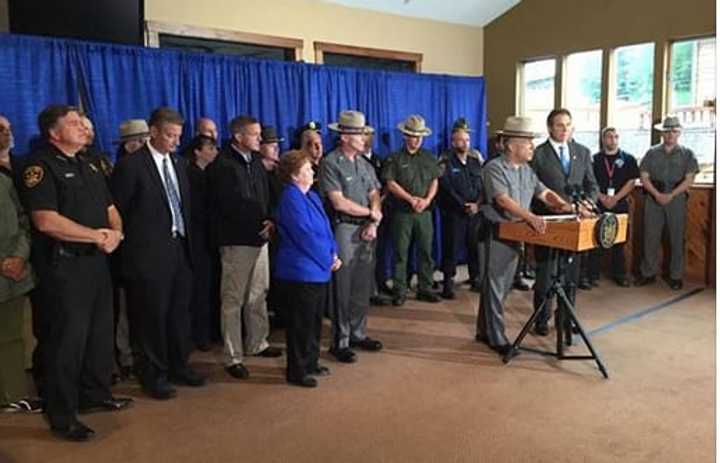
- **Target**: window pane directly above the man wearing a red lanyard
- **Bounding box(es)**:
[608,43,655,159]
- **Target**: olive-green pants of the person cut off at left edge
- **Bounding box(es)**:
[0,296,27,406]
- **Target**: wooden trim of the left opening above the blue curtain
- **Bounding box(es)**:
[145,21,303,61]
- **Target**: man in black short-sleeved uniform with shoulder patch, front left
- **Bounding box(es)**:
[22,105,131,441]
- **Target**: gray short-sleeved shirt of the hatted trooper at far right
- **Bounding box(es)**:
[640,143,700,189]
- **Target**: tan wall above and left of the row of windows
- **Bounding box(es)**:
[484,0,715,129]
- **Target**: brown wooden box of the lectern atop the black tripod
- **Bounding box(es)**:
[498,214,628,252]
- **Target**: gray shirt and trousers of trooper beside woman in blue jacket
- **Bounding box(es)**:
[320,149,380,350]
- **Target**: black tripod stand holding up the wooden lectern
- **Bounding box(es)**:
[503,248,608,379]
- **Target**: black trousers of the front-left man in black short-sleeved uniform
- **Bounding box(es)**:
[42,255,113,428]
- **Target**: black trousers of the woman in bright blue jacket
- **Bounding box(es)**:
[277,280,328,379]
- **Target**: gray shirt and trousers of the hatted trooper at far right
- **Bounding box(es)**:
[640,144,699,280]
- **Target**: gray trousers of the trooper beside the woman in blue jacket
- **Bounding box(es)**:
[331,223,375,349]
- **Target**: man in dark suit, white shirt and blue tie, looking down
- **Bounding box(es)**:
[112,108,205,399]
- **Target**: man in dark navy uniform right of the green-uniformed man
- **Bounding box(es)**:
[438,118,482,299]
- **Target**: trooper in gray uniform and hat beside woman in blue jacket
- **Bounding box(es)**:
[320,110,383,363]
